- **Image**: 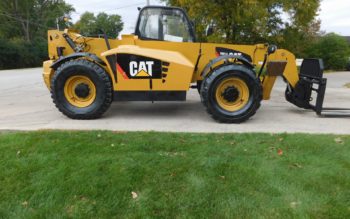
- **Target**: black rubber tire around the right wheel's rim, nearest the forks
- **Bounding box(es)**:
[201,64,262,123]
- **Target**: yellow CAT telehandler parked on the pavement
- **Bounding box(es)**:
[43,6,348,123]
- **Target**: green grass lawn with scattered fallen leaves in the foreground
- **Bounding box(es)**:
[0,131,350,218]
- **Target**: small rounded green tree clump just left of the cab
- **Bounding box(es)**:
[74,12,124,38]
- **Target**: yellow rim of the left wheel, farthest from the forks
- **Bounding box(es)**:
[64,75,96,108]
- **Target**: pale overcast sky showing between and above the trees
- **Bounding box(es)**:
[66,0,350,36]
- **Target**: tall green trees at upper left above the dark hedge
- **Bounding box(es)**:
[0,0,74,42]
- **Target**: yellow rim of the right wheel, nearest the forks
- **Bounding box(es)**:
[215,78,250,112]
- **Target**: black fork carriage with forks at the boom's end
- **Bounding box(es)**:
[286,59,350,117]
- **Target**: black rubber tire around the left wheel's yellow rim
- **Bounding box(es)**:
[51,59,113,120]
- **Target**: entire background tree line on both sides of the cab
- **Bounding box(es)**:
[0,0,350,70]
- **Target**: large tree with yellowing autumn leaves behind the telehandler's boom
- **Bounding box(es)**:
[164,0,320,57]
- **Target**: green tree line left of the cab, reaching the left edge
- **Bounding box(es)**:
[0,0,123,69]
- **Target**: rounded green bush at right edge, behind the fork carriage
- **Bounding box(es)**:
[307,33,350,70]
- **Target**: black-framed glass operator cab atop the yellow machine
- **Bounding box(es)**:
[135,6,196,42]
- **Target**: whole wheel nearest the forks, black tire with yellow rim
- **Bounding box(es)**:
[201,65,262,123]
